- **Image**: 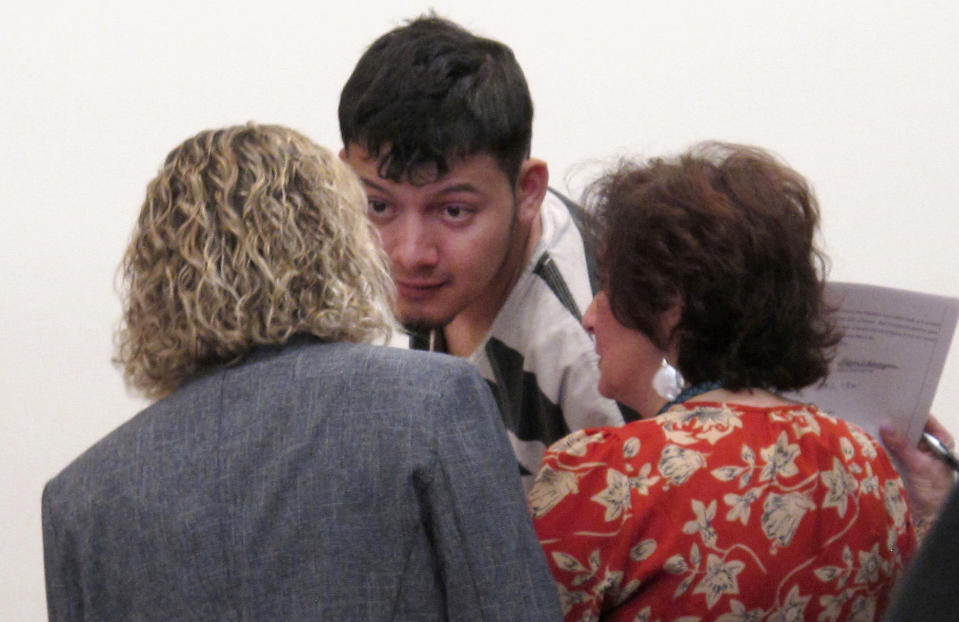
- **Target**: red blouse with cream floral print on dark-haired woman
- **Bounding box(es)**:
[529,402,916,622]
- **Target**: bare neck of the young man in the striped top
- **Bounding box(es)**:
[443,208,543,358]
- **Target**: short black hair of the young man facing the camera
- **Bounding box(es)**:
[339,15,533,183]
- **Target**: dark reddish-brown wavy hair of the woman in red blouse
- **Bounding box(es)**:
[586,143,840,391]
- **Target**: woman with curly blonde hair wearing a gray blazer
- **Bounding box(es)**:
[43,124,559,621]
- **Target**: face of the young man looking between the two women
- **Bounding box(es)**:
[341,145,538,329]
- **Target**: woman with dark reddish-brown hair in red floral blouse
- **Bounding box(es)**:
[529,143,915,621]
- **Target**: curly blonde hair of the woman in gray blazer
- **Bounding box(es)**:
[114,123,395,398]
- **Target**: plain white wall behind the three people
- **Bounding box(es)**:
[0,0,959,620]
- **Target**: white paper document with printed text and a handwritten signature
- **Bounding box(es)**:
[789,282,959,443]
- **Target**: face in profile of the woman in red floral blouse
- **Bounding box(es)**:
[583,291,665,417]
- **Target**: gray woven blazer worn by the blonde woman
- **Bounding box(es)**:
[43,339,561,622]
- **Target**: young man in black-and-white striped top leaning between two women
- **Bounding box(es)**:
[339,17,623,485]
